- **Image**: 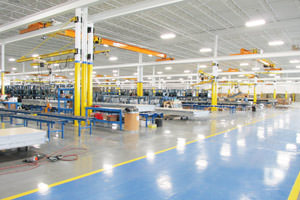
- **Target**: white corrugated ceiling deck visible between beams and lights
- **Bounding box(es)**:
[0,0,300,81]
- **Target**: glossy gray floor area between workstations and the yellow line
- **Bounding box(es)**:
[0,110,285,198]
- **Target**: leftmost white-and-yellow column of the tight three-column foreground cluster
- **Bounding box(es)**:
[74,8,82,126]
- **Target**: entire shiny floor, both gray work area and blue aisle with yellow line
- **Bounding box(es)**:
[0,109,300,200]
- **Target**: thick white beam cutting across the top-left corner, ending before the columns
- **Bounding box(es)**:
[0,0,104,33]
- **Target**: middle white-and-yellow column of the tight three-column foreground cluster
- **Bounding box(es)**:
[81,8,88,120]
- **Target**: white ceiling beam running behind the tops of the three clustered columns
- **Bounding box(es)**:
[0,0,183,44]
